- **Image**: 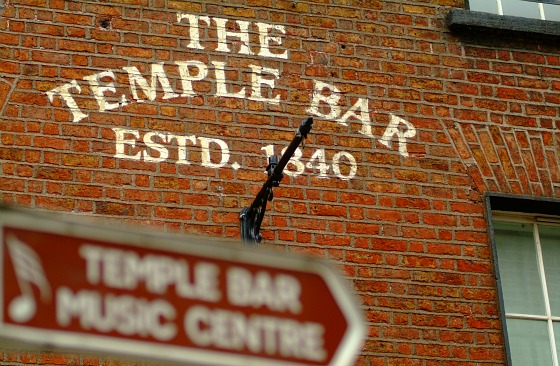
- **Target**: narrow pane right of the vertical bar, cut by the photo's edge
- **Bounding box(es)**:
[539,225,560,316]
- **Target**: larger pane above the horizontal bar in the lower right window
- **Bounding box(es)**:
[494,223,545,315]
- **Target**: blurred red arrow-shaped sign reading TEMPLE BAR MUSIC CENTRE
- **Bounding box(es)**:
[0,209,365,366]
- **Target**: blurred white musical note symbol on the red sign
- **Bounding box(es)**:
[6,234,51,323]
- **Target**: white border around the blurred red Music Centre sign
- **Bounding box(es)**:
[0,206,367,366]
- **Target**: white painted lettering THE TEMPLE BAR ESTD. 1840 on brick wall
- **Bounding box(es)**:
[46,13,416,179]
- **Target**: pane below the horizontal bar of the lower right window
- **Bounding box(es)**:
[506,319,552,366]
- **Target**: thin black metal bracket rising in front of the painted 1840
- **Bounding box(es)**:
[239,117,313,246]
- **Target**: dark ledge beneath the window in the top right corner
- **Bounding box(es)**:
[447,8,560,37]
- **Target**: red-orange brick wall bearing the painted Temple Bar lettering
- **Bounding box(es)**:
[0,0,560,366]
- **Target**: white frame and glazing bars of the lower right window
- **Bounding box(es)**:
[492,211,560,366]
